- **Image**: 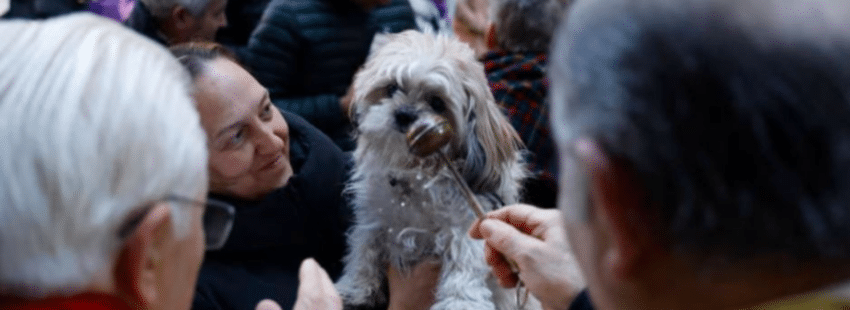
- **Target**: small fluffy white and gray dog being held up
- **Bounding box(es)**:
[336,31,527,309]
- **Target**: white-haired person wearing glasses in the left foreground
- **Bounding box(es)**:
[0,14,333,309]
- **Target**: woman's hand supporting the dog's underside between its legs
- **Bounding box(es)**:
[387,261,441,310]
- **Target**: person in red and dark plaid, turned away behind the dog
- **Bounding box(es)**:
[482,0,572,208]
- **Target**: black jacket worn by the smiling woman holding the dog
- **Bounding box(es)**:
[192,112,352,310]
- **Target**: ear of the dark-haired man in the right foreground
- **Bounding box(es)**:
[576,139,654,280]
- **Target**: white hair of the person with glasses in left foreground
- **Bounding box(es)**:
[0,13,208,298]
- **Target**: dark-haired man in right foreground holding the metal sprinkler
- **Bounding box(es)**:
[471,0,850,309]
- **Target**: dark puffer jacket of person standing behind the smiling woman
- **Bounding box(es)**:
[240,0,416,150]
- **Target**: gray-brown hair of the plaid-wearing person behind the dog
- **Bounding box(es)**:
[489,0,574,53]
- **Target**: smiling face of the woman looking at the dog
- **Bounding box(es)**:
[195,57,293,199]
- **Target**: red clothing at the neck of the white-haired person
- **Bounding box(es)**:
[0,293,133,310]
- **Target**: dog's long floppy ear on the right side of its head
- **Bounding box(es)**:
[459,62,522,194]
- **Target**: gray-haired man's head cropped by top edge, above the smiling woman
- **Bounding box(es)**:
[124,0,227,46]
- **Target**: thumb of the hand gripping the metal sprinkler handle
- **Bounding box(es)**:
[480,219,541,263]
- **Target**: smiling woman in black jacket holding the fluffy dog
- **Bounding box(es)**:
[171,43,439,309]
